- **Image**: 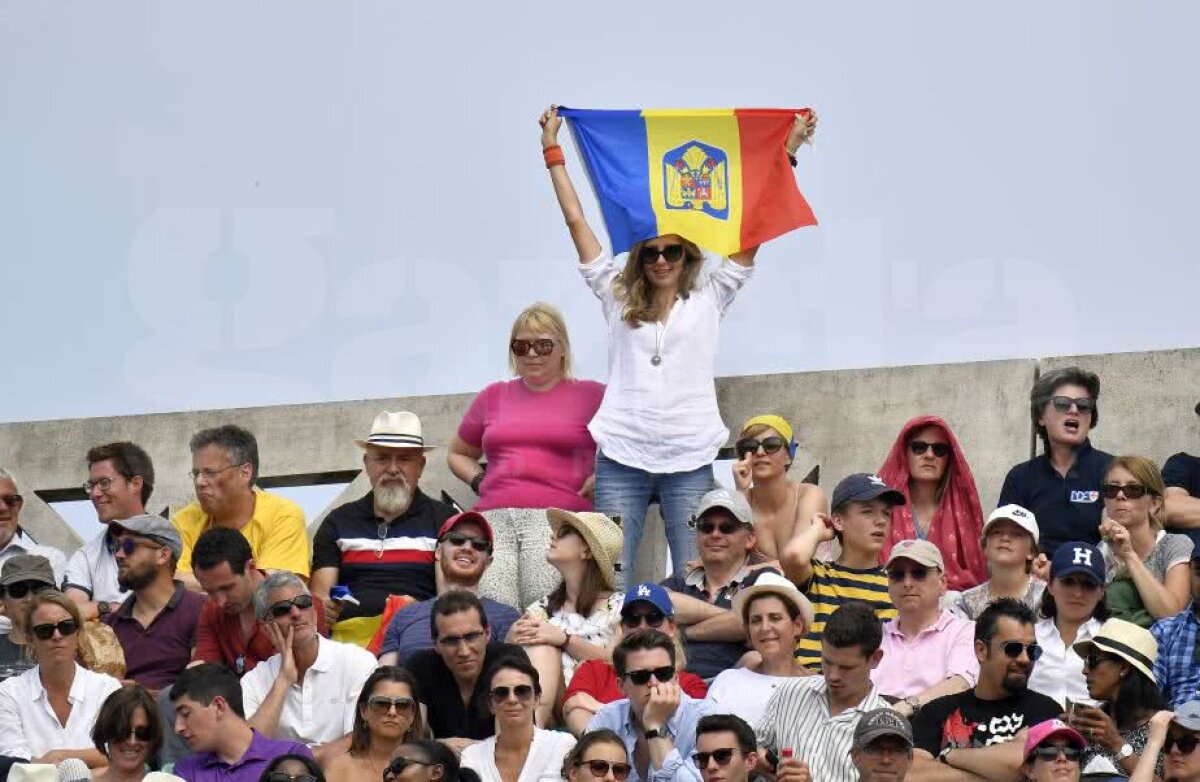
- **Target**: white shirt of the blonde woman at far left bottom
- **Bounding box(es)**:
[0,663,121,758]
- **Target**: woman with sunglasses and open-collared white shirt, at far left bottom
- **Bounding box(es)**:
[0,590,121,769]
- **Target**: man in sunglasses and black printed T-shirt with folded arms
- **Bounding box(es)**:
[912,597,1062,781]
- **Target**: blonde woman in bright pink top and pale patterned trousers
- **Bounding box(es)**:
[446,301,604,606]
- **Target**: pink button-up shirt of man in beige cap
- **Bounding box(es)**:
[871,610,979,698]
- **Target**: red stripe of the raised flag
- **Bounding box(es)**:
[734,109,817,248]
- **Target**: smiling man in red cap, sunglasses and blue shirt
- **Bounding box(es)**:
[379,511,521,666]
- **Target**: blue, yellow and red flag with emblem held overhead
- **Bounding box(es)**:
[558,108,817,255]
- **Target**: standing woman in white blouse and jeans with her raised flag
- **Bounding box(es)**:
[539,106,816,587]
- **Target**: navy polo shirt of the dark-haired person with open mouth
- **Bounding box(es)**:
[1000,440,1112,559]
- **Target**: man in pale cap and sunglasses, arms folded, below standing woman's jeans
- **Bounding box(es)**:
[662,488,779,680]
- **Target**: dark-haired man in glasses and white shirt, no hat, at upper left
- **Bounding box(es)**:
[62,443,154,619]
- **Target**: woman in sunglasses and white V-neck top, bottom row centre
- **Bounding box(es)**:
[460,656,575,782]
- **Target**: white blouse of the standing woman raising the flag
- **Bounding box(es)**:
[580,257,754,473]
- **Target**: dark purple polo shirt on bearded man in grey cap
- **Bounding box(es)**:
[104,581,204,690]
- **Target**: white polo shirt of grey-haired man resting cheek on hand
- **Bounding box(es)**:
[238,636,378,745]
